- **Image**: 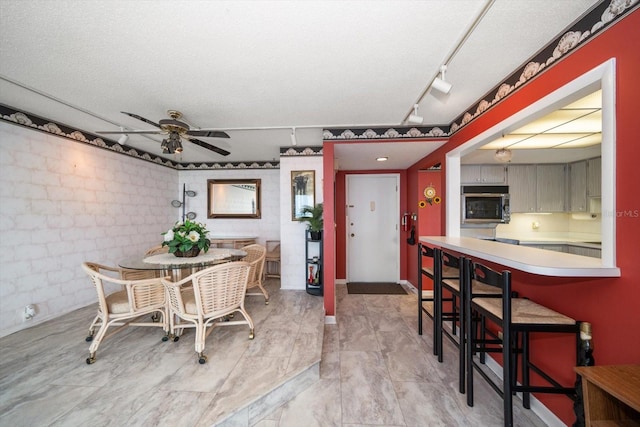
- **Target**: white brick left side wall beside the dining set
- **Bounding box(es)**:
[0,123,179,336]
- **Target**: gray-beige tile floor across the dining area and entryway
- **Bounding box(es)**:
[0,279,545,427]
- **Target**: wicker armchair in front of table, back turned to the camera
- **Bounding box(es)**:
[162,261,254,364]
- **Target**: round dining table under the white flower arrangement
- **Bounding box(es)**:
[118,248,247,280]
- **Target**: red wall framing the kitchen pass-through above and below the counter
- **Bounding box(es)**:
[409,11,640,425]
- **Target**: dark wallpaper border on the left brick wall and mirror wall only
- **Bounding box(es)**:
[0,104,280,170]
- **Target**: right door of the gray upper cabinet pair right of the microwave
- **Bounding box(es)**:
[536,164,566,212]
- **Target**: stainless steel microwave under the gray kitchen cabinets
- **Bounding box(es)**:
[460,185,511,224]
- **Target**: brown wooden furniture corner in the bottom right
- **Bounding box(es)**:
[575,365,640,427]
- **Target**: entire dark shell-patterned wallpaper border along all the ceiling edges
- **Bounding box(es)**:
[0,0,640,166]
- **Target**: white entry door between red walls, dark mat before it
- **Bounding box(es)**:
[346,174,400,283]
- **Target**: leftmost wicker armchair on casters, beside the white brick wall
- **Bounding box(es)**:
[82,262,169,364]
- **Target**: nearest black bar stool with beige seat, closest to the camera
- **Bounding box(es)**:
[463,259,580,426]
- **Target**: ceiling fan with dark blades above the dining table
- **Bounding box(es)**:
[96,110,231,156]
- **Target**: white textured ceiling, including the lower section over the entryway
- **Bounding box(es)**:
[0,0,597,169]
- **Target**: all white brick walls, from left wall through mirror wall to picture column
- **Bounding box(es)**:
[0,122,322,336]
